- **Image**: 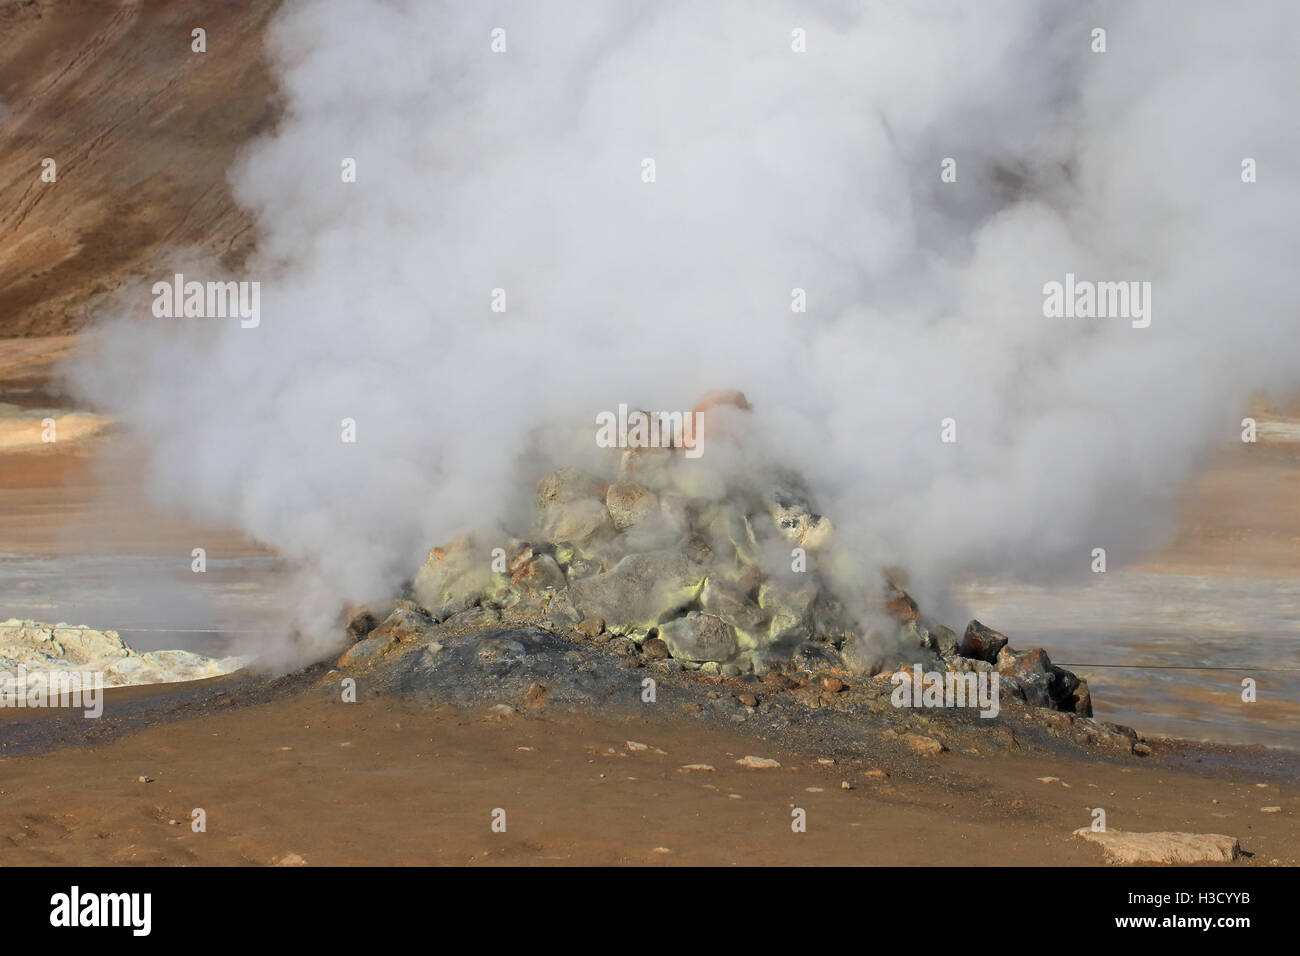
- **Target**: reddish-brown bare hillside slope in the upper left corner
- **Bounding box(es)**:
[0,0,278,338]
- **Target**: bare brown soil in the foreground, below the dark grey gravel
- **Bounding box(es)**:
[0,697,1300,865]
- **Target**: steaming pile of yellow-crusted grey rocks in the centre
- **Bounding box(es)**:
[345,393,1092,715]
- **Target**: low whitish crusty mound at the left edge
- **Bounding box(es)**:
[0,618,251,687]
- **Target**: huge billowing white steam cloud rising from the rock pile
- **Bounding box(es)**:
[68,0,1300,650]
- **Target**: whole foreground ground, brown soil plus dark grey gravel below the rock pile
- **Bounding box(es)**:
[0,631,1300,866]
